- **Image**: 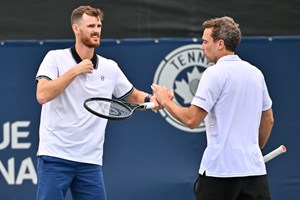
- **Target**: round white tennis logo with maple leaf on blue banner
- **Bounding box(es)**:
[153,44,211,132]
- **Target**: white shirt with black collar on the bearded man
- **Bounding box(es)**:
[36,49,133,165]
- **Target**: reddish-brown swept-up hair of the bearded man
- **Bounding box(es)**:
[71,6,104,24]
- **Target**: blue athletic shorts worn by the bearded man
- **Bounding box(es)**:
[36,156,107,200]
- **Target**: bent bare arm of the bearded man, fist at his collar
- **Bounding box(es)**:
[36,59,94,104]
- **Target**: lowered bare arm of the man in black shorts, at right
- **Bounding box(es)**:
[259,108,274,149]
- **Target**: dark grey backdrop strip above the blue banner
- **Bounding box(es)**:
[0,0,300,40]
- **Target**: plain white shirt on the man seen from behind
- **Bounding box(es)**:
[192,55,272,177]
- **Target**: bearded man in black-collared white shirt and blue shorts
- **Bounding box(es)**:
[36,6,159,200]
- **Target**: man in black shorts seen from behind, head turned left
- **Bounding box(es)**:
[151,16,274,200]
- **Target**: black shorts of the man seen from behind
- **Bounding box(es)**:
[195,175,271,200]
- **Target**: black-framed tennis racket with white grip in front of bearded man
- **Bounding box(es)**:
[83,97,155,120]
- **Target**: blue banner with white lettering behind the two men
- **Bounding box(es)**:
[0,37,300,200]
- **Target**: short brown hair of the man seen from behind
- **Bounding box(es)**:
[202,16,242,51]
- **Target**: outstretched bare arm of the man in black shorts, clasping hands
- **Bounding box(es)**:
[151,84,207,128]
